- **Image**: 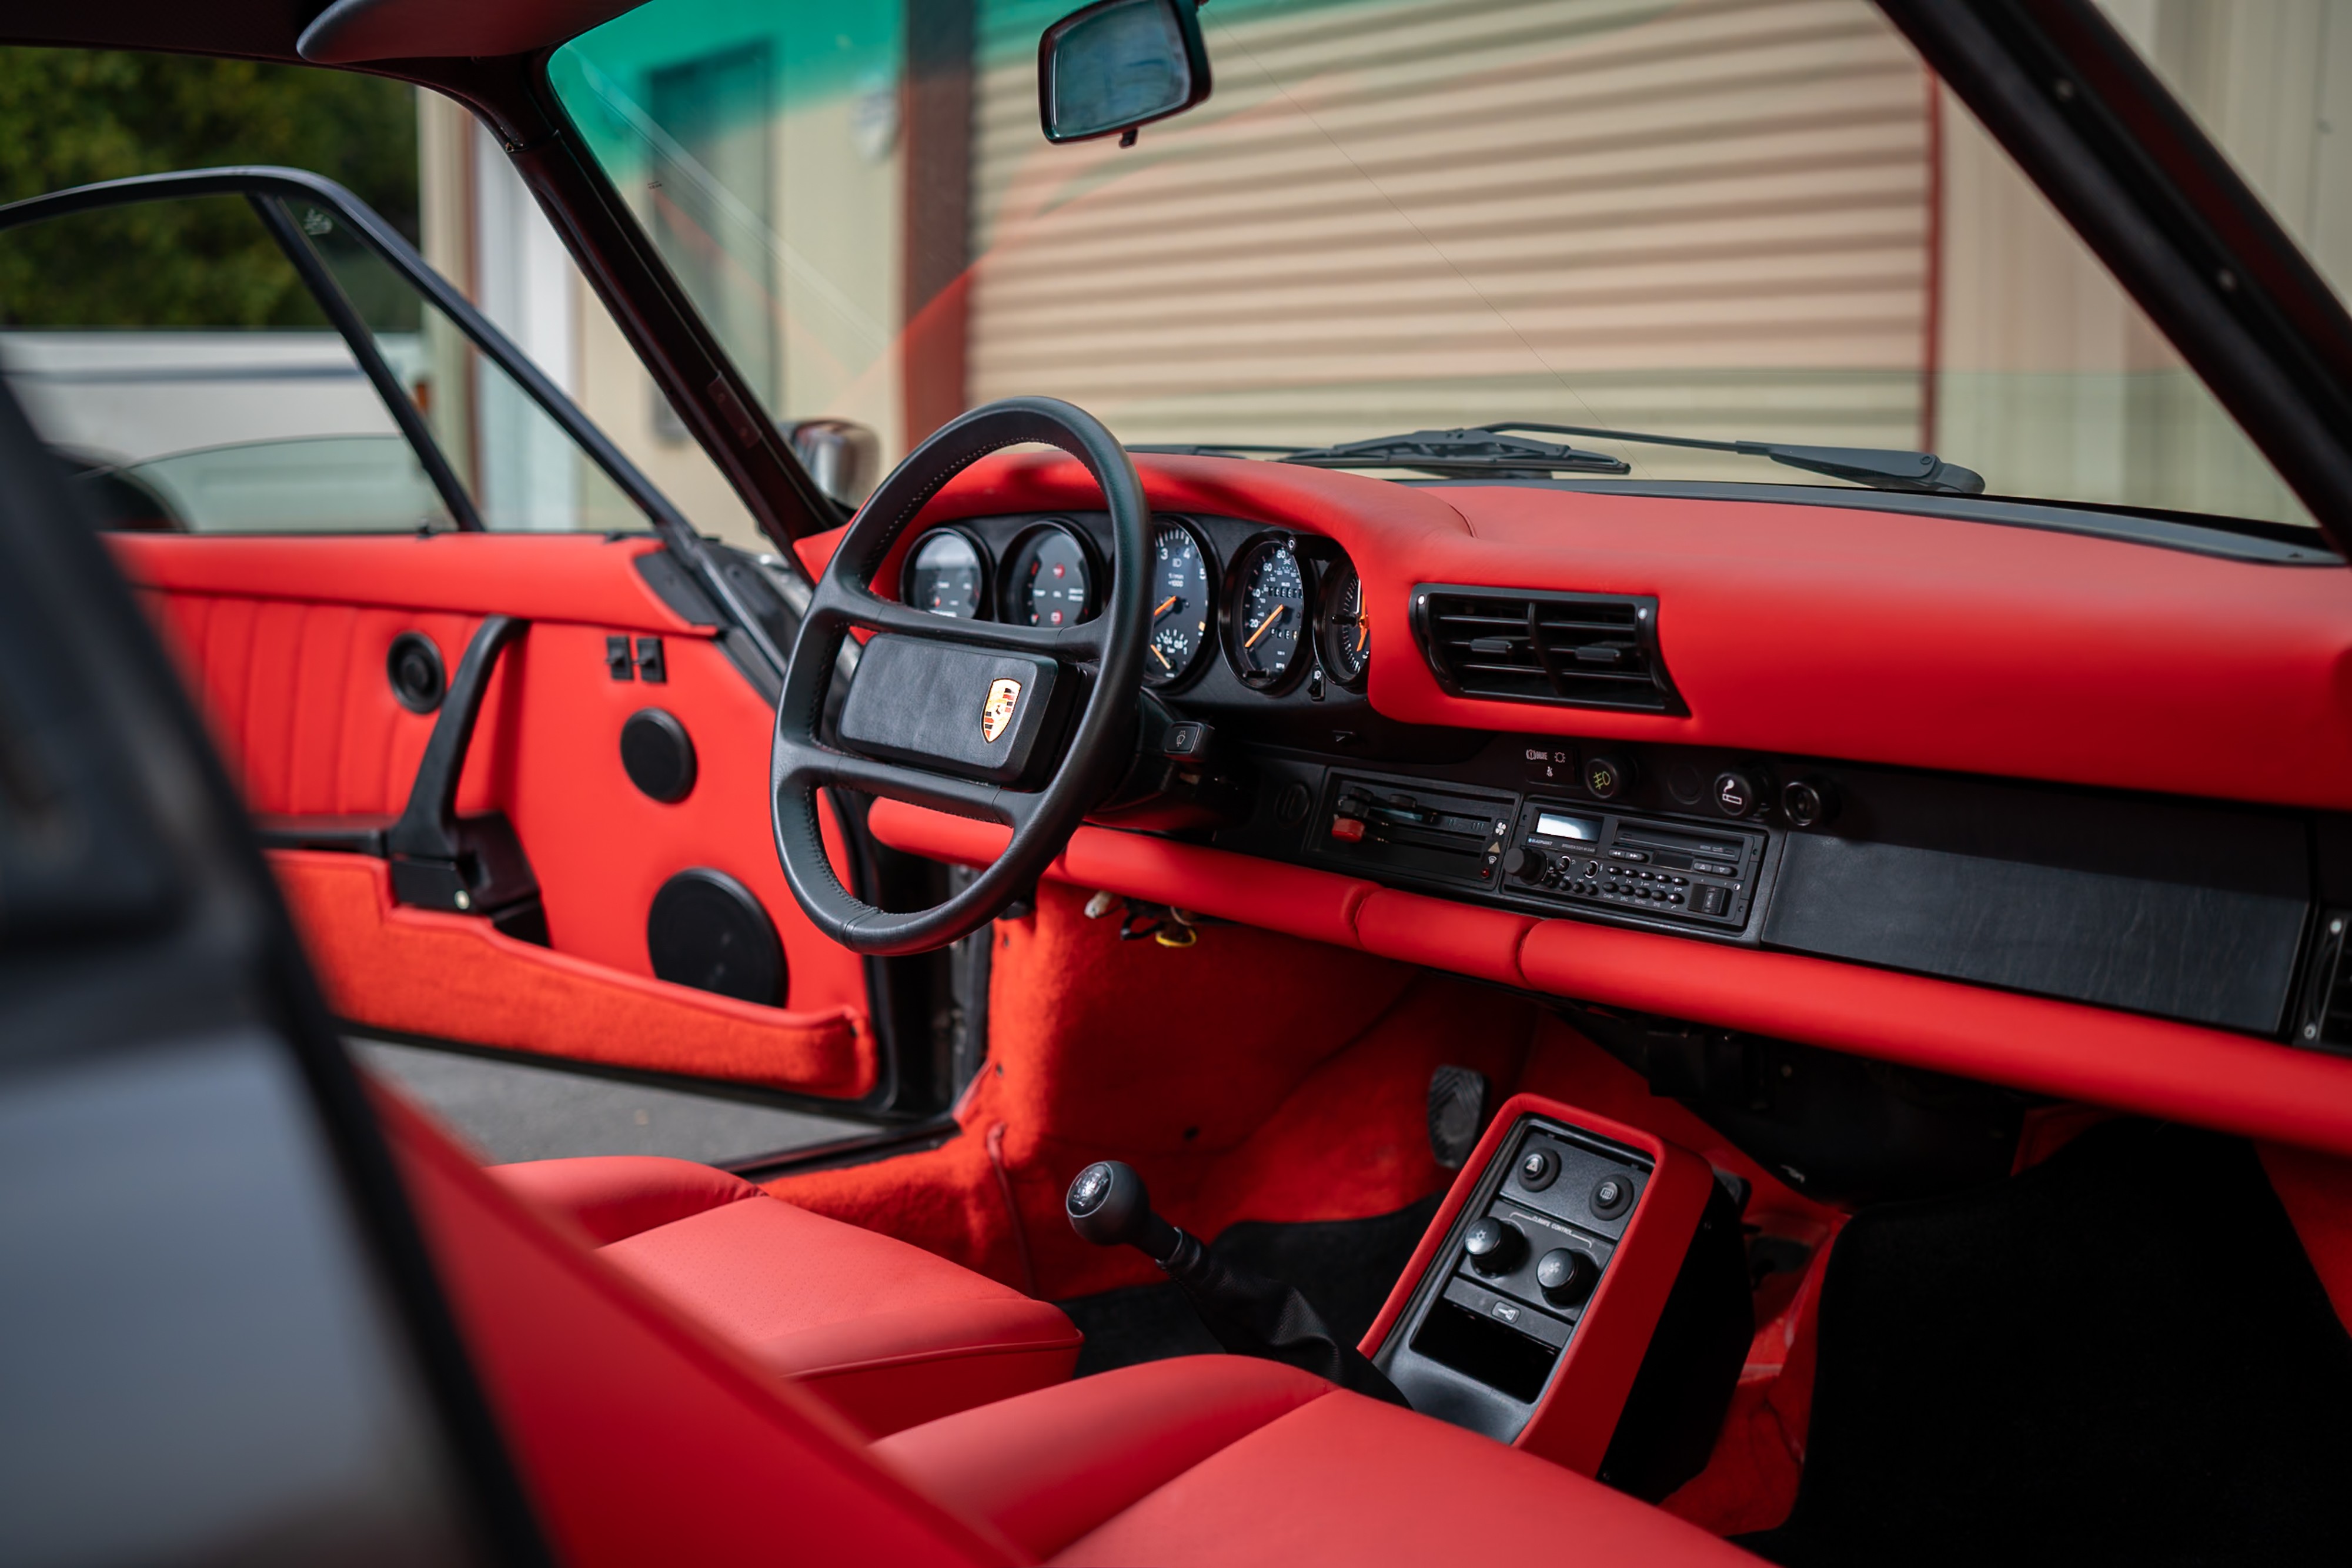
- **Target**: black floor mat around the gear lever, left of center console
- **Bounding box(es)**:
[1061,1192,1444,1378]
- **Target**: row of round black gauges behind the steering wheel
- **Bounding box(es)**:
[898,515,1371,696]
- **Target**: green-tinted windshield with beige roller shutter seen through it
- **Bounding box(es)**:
[550,0,2352,522]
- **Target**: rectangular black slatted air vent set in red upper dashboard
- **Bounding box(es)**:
[1414,583,1689,715]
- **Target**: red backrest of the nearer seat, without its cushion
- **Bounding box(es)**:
[376,1091,1023,1568]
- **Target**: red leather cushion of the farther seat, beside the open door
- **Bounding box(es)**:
[489,1154,1080,1436]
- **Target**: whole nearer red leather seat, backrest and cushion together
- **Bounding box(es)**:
[383,1102,1757,1568]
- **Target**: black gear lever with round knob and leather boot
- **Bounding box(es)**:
[1063,1159,1406,1406]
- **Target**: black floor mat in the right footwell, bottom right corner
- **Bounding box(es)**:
[1743,1124,2352,1568]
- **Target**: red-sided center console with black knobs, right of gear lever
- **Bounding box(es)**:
[1362,1095,1755,1497]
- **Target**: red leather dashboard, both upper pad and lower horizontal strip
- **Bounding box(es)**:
[823,456,2352,1152]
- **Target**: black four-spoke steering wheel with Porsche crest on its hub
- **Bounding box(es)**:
[769,397,1150,957]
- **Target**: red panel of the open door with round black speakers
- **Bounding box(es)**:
[113,534,875,1095]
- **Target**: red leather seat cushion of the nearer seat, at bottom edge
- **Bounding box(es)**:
[873,1356,1755,1568]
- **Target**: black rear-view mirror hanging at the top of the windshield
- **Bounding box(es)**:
[1037,0,1209,146]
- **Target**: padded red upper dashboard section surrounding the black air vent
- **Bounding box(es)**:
[802,442,2352,808]
